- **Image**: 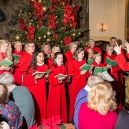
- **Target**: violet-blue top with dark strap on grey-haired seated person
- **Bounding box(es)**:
[73,89,88,129]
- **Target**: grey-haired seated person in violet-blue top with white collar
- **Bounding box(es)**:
[73,74,104,129]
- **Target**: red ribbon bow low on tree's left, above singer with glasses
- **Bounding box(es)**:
[26,25,35,41]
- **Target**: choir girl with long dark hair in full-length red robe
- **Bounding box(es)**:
[25,50,48,124]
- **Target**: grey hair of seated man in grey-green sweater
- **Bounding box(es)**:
[0,72,14,86]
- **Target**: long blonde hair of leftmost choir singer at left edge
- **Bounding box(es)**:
[0,40,12,61]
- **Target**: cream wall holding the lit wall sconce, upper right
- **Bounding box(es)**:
[89,0,125,41]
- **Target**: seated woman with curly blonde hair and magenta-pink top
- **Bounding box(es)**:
[78,82,117,129]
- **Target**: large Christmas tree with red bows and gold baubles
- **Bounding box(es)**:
[10,0,85,50]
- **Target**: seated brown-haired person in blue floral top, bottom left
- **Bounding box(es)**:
[0,83,23,129]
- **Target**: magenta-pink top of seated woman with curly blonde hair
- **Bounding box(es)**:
[78,103,117,129]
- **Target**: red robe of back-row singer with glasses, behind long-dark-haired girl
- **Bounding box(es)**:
[19,52,33,85]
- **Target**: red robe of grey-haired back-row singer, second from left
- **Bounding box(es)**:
[13,50,25,85]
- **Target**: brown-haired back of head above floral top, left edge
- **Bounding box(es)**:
[0,83,9,104]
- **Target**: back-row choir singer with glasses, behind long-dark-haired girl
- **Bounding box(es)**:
[19,42,35,85]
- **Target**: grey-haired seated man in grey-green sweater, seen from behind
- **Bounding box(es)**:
[0,72,35,129]
